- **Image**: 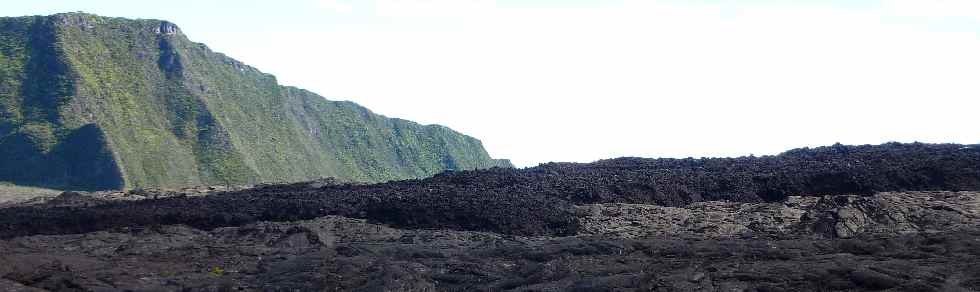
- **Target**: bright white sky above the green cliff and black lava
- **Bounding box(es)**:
[0,0,980,167]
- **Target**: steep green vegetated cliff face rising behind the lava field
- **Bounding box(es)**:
[0,13,510,190]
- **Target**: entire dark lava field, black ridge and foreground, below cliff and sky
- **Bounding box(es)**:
[0,143,980,291]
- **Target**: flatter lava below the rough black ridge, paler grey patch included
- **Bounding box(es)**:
[0,192,980,291]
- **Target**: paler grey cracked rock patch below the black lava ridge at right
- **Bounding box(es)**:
[575,192,980,238]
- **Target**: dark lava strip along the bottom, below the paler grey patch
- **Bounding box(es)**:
[0,212,980,291]
